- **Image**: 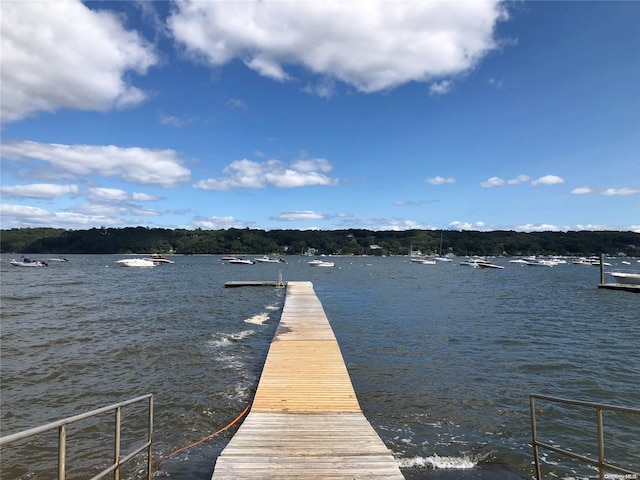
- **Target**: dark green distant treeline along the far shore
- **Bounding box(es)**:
[0,227,640,256]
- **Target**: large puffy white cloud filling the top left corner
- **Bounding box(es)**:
[0,1,157,122]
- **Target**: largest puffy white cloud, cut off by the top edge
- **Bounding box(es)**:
[168,0,507,95]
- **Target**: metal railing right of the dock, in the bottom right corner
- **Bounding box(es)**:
[529,394,640,480]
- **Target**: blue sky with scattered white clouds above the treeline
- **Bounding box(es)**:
[0,0,640,232]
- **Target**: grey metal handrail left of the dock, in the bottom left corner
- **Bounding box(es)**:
[0,393,153,480]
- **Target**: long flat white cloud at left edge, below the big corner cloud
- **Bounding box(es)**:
[0,141,191,188]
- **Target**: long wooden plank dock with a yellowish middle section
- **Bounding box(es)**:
[212,282,404,480]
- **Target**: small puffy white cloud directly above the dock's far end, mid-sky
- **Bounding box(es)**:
[194,158,338,191]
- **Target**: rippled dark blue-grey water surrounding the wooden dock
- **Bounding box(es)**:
[0,255,640,480]
